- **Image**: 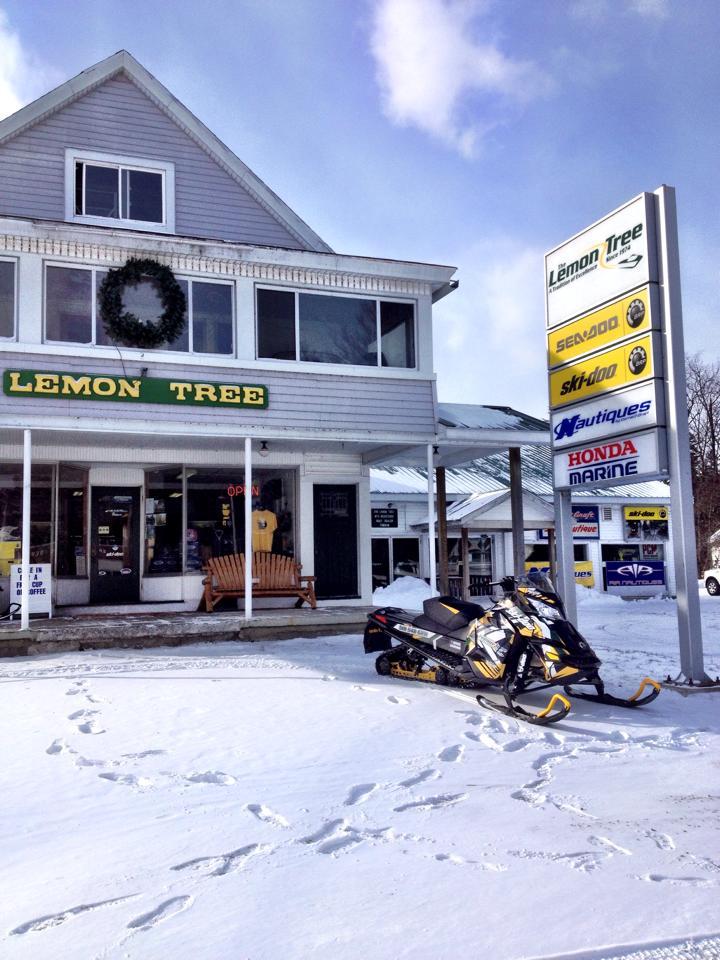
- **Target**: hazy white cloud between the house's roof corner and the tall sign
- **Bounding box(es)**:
[433,237,547,416]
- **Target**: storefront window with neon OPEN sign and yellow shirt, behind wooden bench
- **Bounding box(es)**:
[186,467,295,570]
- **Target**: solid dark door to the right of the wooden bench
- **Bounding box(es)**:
[313,484,360,600]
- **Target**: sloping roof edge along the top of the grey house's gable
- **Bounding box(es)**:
[0,50,333,253]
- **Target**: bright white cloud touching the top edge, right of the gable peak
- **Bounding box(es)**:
[371,0,550,157]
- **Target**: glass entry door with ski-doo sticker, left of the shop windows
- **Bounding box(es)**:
[90,487,140,603]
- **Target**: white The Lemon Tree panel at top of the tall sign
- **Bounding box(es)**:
[545,193,657,327]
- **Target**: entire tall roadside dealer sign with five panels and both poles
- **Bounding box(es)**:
[545,186,707,683]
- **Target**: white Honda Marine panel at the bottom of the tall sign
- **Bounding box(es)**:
[553,430,667,490]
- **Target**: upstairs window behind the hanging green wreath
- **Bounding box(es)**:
[45,265,233,356]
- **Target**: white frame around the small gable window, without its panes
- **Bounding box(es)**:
[65,147,175,233]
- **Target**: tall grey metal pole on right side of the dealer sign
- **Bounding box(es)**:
[655,186,708,683]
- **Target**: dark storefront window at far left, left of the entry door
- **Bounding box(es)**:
[0,463,53,576]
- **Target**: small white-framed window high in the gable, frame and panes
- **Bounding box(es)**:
[65,150,175,233]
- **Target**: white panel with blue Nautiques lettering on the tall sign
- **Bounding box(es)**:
[552,380,665,450]
